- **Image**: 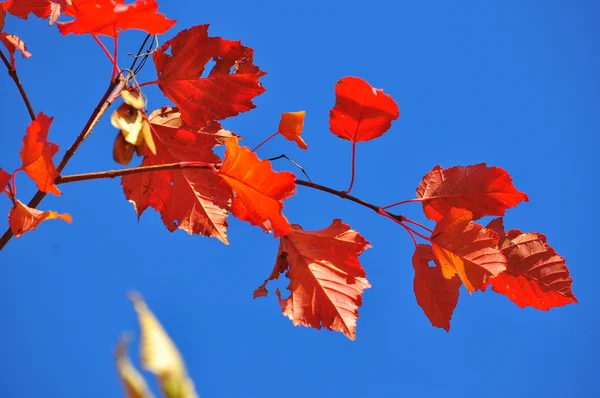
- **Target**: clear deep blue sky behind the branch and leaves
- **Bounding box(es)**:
[0,0,600,398]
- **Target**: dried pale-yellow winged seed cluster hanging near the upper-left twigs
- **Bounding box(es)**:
[110,91,156,166]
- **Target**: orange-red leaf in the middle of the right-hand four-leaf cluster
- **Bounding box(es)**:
[431,208,506,292]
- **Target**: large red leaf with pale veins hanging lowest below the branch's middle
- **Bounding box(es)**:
[254,219,372,340]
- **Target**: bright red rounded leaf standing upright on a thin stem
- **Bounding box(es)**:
[329,77,400,142]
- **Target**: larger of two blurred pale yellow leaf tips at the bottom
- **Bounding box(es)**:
[130,293,198,398]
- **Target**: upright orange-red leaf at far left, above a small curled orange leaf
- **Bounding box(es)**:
[21,112,61,195]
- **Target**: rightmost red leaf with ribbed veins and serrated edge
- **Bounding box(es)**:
[482,219,577,311]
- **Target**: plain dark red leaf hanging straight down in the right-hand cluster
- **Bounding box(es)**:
[412,244,461,332]
